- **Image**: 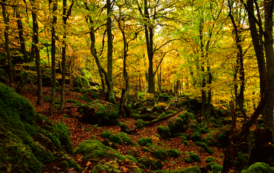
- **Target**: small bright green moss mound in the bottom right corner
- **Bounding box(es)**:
[241,162,274,173]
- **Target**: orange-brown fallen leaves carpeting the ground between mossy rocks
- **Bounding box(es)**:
[20,86,233,172]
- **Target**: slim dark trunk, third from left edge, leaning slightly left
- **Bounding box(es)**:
[32,0,42,106]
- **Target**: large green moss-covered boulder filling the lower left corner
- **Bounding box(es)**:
[0,83,80,173]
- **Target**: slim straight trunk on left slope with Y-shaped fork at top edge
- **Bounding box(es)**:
[59,0,74,112]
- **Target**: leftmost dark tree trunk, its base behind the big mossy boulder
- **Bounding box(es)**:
[2,0,14,87]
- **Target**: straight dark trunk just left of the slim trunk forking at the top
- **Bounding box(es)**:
[49,0,57,115]
